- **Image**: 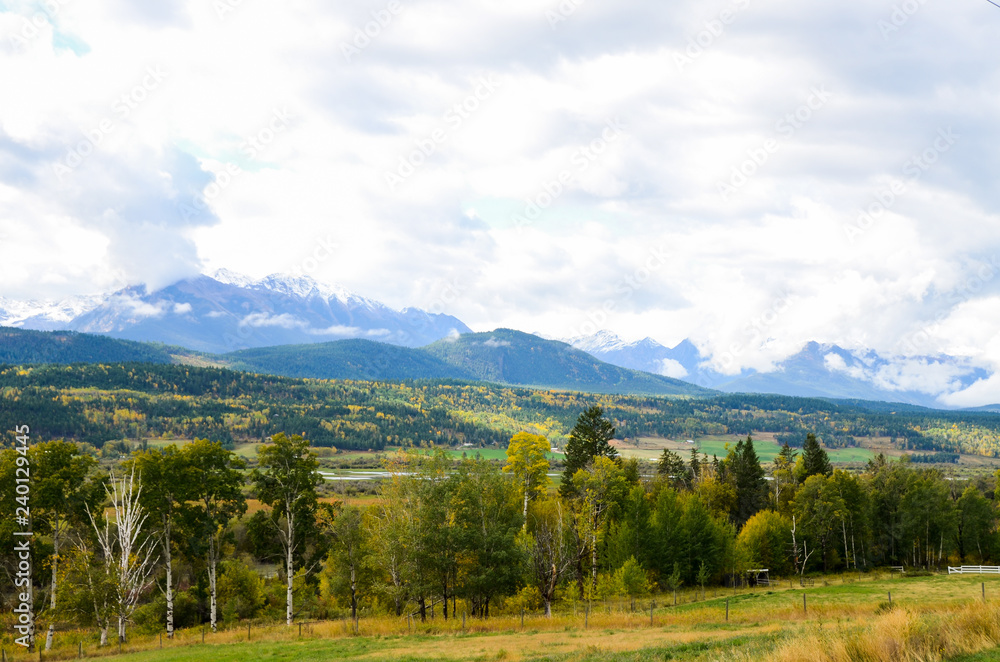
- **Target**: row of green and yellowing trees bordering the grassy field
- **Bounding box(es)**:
[0,406,1000,647]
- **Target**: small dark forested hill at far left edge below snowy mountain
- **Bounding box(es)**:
[0,326,173,365]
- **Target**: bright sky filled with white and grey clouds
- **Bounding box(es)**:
[0,0,1000,406]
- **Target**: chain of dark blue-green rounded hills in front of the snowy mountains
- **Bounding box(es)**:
[0,327,715,396]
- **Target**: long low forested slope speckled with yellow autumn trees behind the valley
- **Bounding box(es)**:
[0,363,1000,456]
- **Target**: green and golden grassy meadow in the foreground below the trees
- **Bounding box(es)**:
[15,573,1000,662]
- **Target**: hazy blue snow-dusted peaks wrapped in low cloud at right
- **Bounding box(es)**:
[567,331,989,407]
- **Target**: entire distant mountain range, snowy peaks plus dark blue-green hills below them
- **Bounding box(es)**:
[0,270,1000,410]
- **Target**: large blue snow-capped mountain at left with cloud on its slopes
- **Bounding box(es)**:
[7,271,470,353]
